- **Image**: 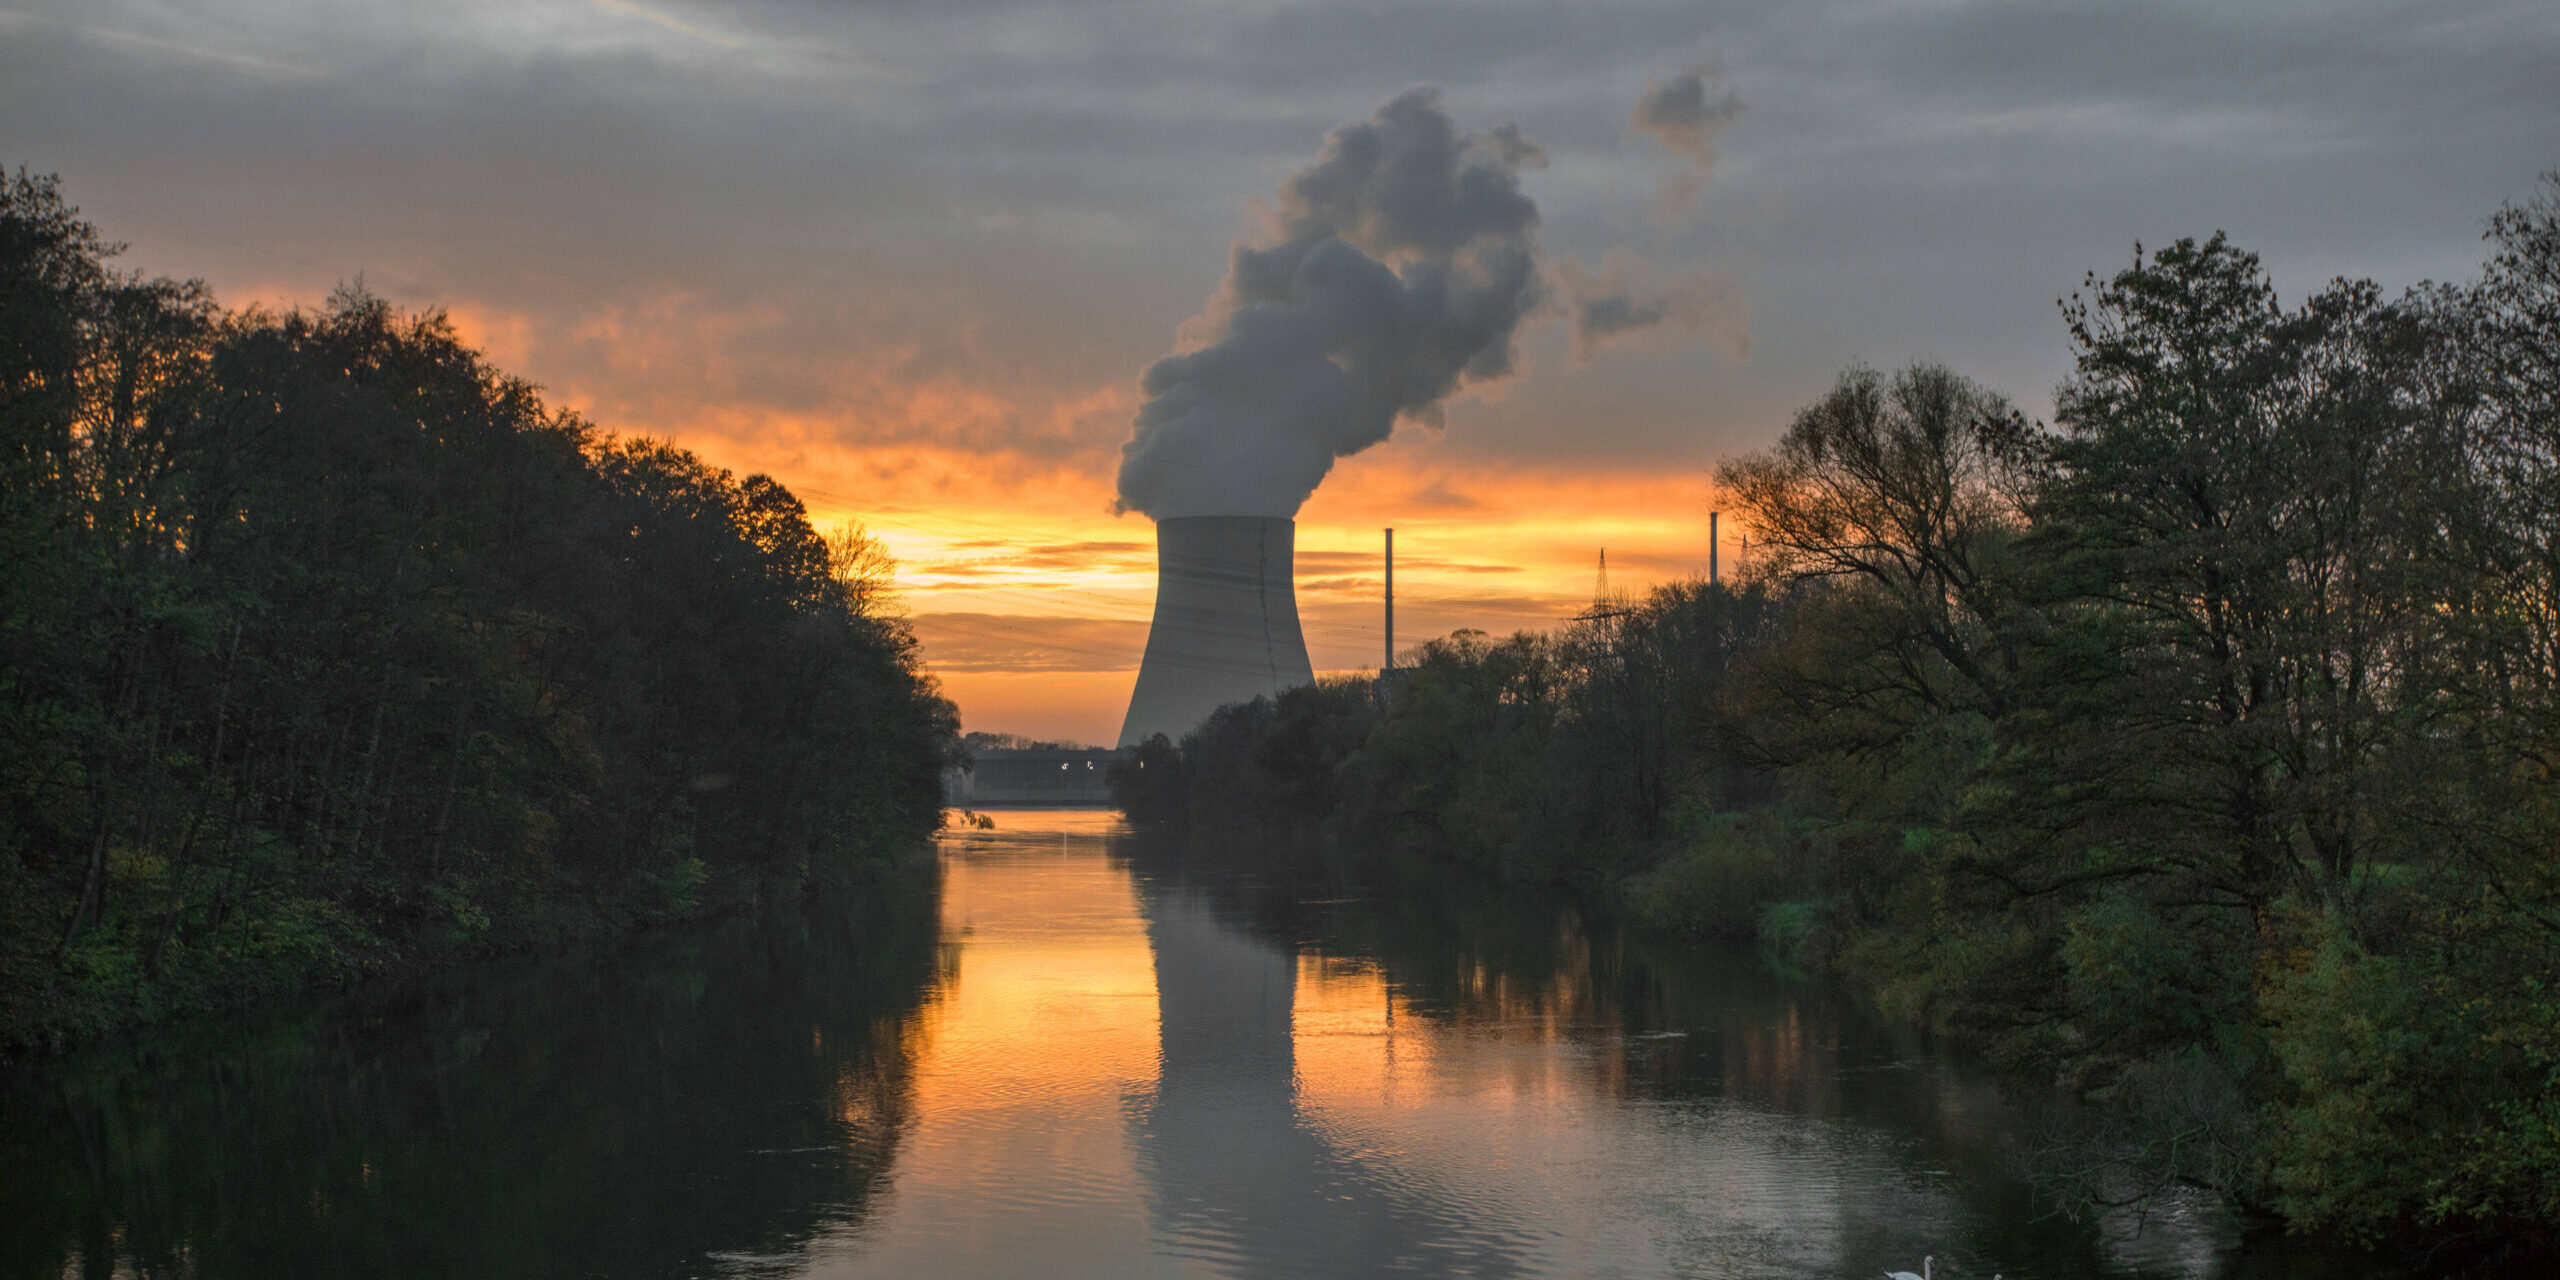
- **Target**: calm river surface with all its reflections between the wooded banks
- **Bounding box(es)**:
[0,812,2344,1280]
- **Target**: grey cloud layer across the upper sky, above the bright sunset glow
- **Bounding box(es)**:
[0,0,2560,488]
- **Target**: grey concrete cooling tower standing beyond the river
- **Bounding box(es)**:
[1119,515,1316,748]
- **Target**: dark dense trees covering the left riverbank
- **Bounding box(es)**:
[0,174,957,1044]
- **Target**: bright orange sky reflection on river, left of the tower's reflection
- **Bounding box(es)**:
[812,814,1157,1275]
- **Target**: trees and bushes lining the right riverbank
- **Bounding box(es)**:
[1114,174,2560,1257]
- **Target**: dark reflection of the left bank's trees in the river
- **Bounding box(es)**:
[0,886,937,1277]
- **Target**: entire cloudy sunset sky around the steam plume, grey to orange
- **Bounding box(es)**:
[0,0,2560,742]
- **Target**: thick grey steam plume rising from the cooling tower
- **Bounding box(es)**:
[1114,90,1546,520]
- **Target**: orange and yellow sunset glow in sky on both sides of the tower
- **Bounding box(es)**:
[435,277,1736,742]
